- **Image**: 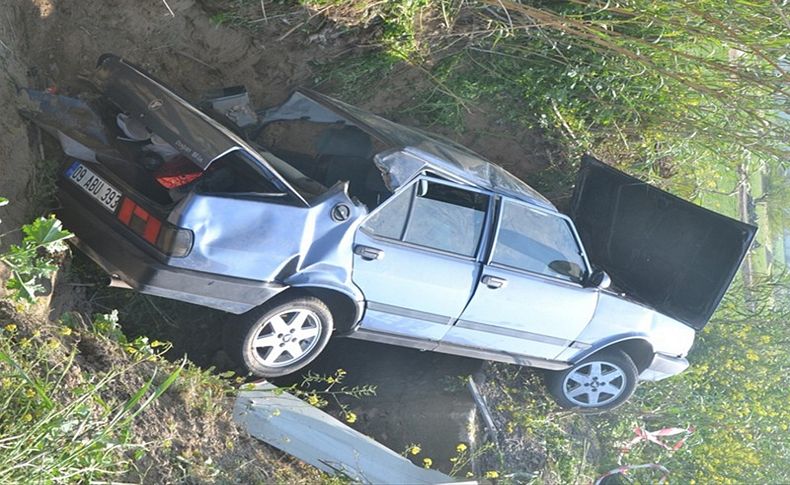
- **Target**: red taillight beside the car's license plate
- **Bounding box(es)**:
[118,197,192,258]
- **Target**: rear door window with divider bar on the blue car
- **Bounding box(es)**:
[362,180,489,256]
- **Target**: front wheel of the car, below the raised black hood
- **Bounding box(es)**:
[546,350,639,414]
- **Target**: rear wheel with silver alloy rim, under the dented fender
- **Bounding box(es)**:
[224,296,334,377]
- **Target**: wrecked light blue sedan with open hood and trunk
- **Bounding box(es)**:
[23,55,756,412]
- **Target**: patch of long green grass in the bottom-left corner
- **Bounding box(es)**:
[0,312,181,483]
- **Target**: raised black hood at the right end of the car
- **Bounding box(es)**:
[571,156,757,330]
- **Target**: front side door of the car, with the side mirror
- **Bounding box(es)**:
[439,198,598,359]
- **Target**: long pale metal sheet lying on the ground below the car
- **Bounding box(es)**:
[233,381,476,485]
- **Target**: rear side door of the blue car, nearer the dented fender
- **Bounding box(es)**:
[352,178,490,348]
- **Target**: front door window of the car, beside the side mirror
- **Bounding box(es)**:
[491,200,585,283]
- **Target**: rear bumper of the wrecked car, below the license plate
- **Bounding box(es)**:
[58,181,287,313]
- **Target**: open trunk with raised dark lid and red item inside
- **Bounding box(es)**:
[22,55,305,212]
